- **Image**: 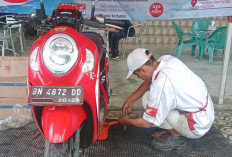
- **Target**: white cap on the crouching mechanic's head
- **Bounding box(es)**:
[126,48,152,79]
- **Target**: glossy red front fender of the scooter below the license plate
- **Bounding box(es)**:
[41,106,87,143]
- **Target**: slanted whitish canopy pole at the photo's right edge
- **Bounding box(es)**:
[218,22,232,105]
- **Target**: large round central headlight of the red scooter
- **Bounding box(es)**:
[42,33,78,75]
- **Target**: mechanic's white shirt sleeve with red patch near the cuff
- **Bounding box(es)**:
[143,71,176,126]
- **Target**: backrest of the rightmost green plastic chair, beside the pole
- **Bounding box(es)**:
[208,27,227,49]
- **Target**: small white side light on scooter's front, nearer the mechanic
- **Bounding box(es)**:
[82,48,94,73]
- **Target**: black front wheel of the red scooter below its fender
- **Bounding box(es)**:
[44,128,80,157]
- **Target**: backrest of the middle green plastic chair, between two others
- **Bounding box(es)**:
[192,19,211,39]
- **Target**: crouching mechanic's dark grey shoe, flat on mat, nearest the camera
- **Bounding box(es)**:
[151,135,188,151]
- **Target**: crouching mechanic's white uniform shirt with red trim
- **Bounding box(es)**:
[143,55,214,136]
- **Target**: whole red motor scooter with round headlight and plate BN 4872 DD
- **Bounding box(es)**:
[14,2,123,157]
